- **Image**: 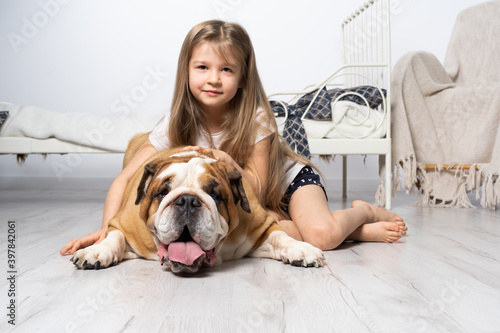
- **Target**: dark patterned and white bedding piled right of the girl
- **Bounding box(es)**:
[270,86,386,158]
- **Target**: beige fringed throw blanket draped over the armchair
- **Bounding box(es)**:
[392,1,500,209]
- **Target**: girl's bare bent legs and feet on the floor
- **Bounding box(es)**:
[279,185,406,250]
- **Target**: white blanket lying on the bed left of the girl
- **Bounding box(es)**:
[0,102,161,152]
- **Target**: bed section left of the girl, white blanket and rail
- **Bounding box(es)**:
[0,102,161,155]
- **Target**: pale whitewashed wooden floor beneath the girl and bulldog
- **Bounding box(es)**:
[0,191,500,332]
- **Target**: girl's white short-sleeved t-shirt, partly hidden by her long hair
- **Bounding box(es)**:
[149,109,304,189]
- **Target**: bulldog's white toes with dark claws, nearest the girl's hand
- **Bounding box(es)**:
[71,244,119,269]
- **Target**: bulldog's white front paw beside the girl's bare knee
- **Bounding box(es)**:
[281,240,325,267]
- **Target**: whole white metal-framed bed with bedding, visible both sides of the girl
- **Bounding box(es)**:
[0,0,392,209]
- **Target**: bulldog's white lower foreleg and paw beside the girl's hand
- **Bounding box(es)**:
[71,230,125,269]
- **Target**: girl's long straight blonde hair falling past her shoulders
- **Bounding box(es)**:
[168,20,311,212]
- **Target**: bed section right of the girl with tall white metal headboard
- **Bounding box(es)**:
[269,0,392,209]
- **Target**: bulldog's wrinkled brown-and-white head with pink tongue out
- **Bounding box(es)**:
[136,151,250,273]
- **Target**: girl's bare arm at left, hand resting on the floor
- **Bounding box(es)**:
[59,139,158,255]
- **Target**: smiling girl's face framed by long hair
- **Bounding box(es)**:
[189,43,241,116]
